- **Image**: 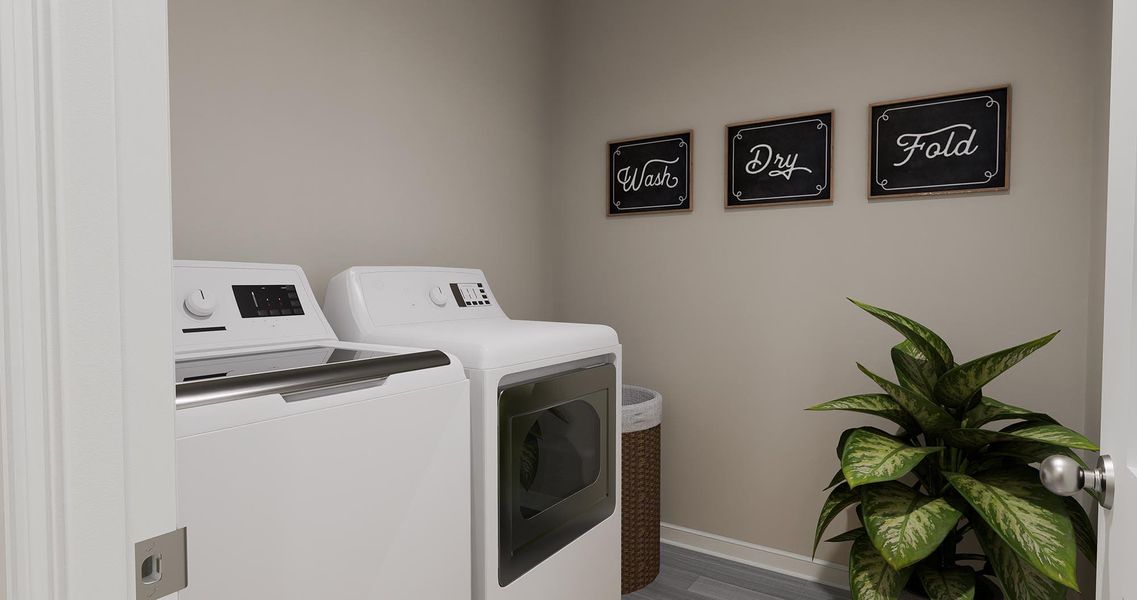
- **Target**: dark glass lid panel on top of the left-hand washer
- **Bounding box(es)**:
[174,345,390,383]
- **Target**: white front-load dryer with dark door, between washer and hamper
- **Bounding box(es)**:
[324,267,621,600]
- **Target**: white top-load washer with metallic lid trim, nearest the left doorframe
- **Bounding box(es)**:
[169,261,471,600]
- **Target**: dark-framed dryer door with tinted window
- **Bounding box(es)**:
[498,365,620,588]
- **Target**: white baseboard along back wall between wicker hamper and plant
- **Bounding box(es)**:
[659,523,849,590]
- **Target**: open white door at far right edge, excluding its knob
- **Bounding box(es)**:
[1097,1,1137,599]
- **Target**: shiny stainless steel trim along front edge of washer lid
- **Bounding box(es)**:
[175,350,450,410]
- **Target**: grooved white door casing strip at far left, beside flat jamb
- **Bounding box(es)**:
[0,0,66,600]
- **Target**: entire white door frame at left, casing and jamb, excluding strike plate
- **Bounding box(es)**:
[0,0,176,600]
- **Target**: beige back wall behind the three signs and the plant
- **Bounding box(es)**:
[549,0,1109,568]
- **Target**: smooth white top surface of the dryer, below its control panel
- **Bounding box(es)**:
[363,317,620,369]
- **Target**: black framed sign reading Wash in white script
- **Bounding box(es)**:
[608,131,691,216]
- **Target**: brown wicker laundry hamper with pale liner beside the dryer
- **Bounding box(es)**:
[620,385,663,594]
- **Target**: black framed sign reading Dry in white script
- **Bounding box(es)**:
[727,111,833,208]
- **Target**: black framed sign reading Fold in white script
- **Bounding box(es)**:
[869,85,1011,198]
